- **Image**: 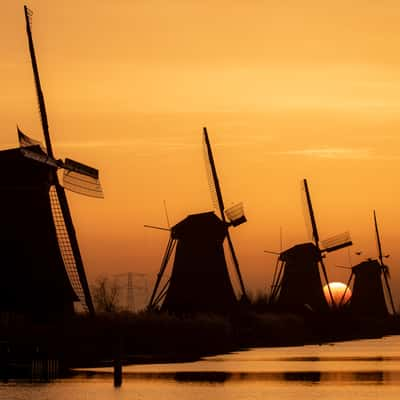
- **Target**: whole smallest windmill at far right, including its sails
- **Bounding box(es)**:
[347,210,396,316]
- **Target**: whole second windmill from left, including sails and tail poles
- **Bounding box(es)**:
[149,128,246,313]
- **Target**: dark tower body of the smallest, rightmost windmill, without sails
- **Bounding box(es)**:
[350,260,388,317]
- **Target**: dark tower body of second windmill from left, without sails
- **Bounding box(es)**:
[161,212,237,314]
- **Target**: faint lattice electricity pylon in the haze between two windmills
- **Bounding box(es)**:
[113,272,149,312]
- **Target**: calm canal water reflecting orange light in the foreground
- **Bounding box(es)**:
[0,336,400,400]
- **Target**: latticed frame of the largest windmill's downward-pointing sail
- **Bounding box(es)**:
[49,185,89,312]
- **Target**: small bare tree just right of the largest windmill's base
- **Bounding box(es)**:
[92,276,121,312]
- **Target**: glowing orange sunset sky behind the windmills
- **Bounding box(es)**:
[0,0,400,303]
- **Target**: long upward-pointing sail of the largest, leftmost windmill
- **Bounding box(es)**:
[24,6,54,158]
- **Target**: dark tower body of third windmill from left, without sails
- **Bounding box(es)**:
[274,243,328,312]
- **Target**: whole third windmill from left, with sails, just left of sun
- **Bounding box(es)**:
[270,179,352,311]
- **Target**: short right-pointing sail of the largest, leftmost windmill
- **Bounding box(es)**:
[63,158,104,198]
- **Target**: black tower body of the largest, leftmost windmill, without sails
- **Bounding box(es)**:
[0,146,78,320]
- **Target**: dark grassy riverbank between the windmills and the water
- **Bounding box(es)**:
[0,310,400,376]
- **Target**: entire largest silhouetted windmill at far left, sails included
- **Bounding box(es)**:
[0,7,102,320]
